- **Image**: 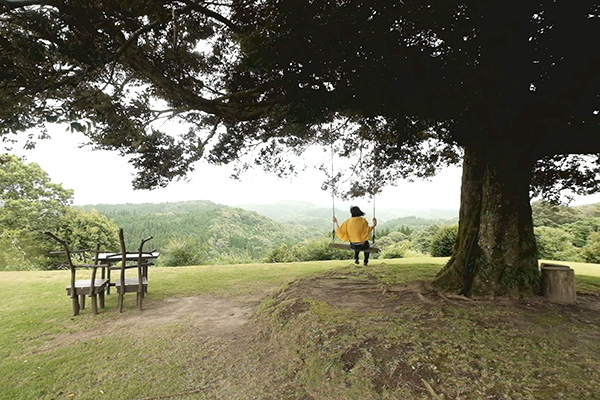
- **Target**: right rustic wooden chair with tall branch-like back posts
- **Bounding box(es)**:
[111,228,154,312]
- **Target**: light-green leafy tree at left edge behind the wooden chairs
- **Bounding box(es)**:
[0,154,119,270]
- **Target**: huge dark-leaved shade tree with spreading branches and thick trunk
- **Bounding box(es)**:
[0,0,600,294]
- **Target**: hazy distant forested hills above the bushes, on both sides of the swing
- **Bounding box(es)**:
[82,201,457,265]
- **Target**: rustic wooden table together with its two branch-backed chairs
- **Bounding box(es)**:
[45,229,160,316]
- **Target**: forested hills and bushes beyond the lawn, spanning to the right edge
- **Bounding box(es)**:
[83,201,600,265]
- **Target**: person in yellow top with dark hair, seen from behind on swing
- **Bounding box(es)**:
[333,206,377,266]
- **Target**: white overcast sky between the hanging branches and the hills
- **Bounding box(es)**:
[4,129,600,210]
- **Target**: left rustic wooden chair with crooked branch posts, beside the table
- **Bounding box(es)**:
[45,232,109,316]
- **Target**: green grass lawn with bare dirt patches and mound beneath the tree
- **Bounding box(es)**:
[0,258,600,400]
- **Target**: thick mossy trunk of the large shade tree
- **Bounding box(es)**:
[433,147,540,295]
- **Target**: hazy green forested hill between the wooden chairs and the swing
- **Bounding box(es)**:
[83,201,324,263]
